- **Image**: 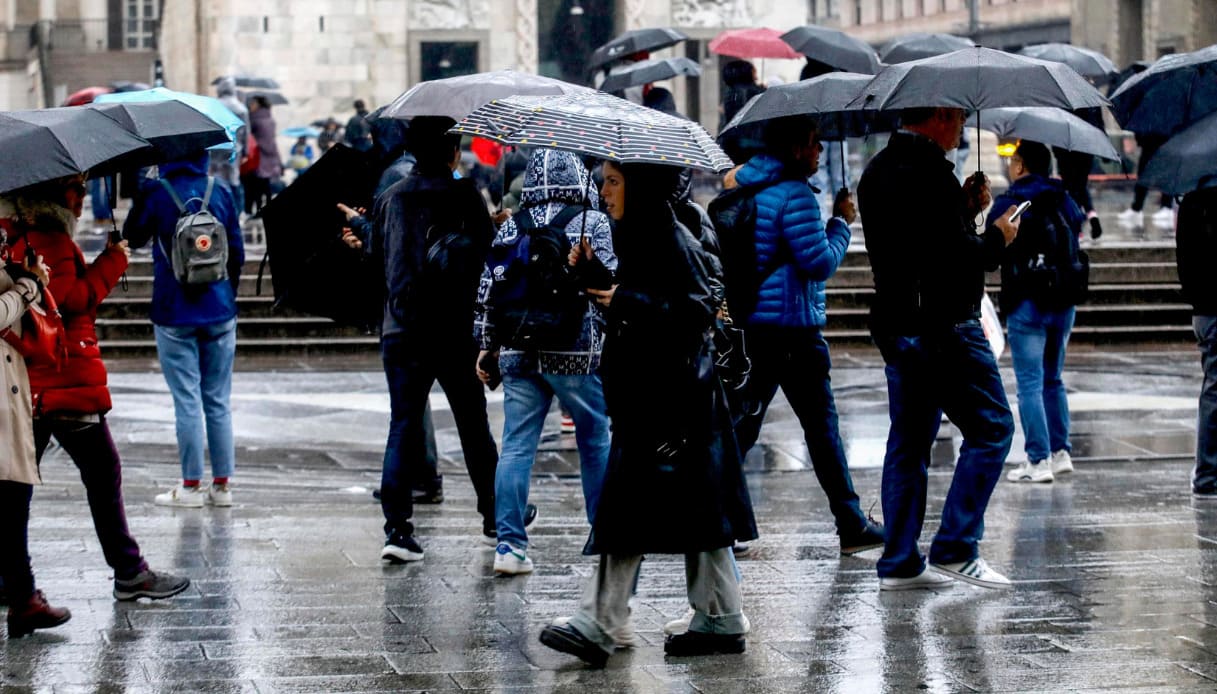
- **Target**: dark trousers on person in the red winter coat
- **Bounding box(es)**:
[34,416,148,580]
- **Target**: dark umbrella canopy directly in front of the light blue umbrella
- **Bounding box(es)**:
[86,101,231,162]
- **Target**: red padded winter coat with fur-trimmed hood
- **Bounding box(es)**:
[12,206,127,416]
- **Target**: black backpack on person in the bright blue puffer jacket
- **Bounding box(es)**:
[707,183,784,316]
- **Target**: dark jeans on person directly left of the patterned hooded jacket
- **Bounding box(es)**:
[381,335,499,538]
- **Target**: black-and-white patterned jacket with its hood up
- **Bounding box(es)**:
[473,149,617,375]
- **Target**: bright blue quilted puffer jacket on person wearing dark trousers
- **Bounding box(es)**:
[735,155,849,328]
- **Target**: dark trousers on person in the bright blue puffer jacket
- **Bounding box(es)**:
[735,325,867,528]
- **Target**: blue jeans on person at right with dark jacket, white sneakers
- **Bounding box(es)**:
[1006,300,1075,463]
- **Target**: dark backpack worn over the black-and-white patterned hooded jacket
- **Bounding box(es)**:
[486,205,588,349]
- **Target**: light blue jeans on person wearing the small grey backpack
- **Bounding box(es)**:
[153,318,236,480]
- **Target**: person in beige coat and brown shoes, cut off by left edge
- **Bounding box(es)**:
[0,245,72,639]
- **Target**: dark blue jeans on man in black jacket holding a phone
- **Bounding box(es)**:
[875,320,1014,578]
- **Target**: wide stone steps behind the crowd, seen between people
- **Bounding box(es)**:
[97,242,1193,358]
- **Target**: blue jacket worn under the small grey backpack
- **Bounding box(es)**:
[123,156,245,325]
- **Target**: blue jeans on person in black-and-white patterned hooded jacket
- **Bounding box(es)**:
[494,368,609,549]
